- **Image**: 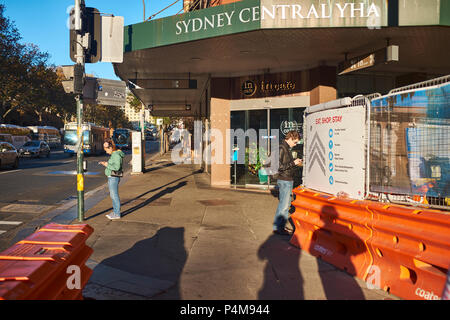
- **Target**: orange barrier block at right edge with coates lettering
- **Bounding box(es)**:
[367,202,450,300]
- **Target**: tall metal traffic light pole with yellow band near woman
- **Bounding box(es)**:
[75,0,84,222]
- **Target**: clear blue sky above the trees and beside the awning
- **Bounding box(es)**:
[0,0,183,80]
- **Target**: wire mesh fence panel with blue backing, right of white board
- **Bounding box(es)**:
[369,76,450,209]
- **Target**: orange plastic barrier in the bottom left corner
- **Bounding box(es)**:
[0,224,94,300]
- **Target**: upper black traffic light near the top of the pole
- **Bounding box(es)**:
[70,5,102,63]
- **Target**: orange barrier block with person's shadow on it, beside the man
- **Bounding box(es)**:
[291,189,373,278]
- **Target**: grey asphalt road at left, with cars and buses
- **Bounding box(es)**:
[0,141,159,251]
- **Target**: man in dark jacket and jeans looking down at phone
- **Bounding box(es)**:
[273,130,303,235]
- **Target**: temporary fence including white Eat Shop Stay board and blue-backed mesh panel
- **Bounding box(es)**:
[303,76,450,210]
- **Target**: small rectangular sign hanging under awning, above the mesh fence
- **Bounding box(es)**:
[338,46,399,76]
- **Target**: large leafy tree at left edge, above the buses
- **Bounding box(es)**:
[0,4,76,126]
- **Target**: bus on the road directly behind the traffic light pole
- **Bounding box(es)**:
[64,122,110,156]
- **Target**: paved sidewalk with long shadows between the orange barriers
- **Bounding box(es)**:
[78,154,396,300]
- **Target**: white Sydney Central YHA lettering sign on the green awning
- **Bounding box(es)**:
[175,0,387,35]
